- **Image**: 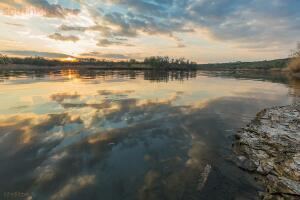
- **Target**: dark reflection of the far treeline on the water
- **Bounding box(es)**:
[0,69,288,84]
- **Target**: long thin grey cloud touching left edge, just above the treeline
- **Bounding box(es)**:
[1,50,72,58]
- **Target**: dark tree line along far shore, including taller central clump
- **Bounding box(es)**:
[0,55,292,70]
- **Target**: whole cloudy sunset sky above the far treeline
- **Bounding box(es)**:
[0,0,300,63]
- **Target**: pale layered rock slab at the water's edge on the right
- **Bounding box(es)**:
[234,103,300,199]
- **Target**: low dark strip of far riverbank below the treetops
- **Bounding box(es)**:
[0,58,289,72]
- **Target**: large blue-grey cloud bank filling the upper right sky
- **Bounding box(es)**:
[73,0,300,49]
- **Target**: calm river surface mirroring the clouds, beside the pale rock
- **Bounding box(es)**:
[0,70,294,200]
